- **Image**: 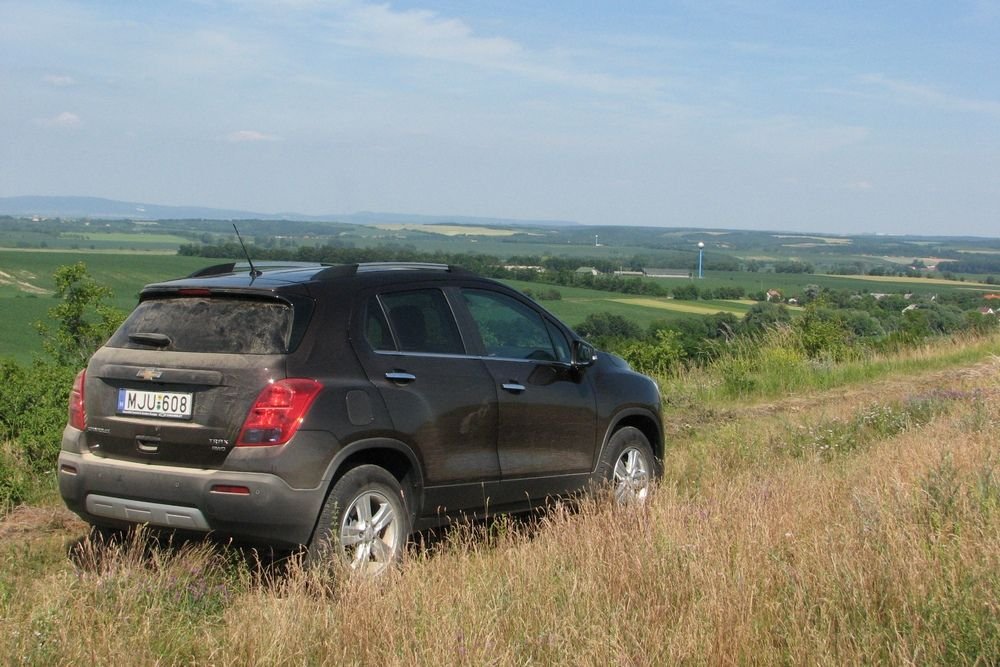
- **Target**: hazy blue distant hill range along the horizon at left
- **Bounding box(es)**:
[0,196,578,227]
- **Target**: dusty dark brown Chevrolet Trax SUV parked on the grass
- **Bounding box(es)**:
[59,263,663,571]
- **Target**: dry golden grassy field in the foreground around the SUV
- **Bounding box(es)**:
[0,341,1000,666]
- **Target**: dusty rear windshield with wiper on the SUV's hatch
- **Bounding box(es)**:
[107,297,294,354]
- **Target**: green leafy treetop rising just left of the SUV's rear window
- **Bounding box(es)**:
[35,262,125,366]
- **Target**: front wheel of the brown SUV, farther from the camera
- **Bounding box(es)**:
[597,426,657,505]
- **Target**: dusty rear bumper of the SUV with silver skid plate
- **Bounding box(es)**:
[58,450,326,546]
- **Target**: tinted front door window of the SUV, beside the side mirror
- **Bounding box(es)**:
[462,289,565,361]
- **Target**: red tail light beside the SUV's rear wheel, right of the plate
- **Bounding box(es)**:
[236,378,322,447]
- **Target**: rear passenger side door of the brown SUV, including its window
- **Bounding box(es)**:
[357,287,500,513]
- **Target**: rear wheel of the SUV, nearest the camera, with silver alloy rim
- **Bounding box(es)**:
[308,465,410,576]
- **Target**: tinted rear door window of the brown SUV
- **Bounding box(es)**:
[376,289,465,354]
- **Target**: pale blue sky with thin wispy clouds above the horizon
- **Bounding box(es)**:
[0,0,1000,236]
